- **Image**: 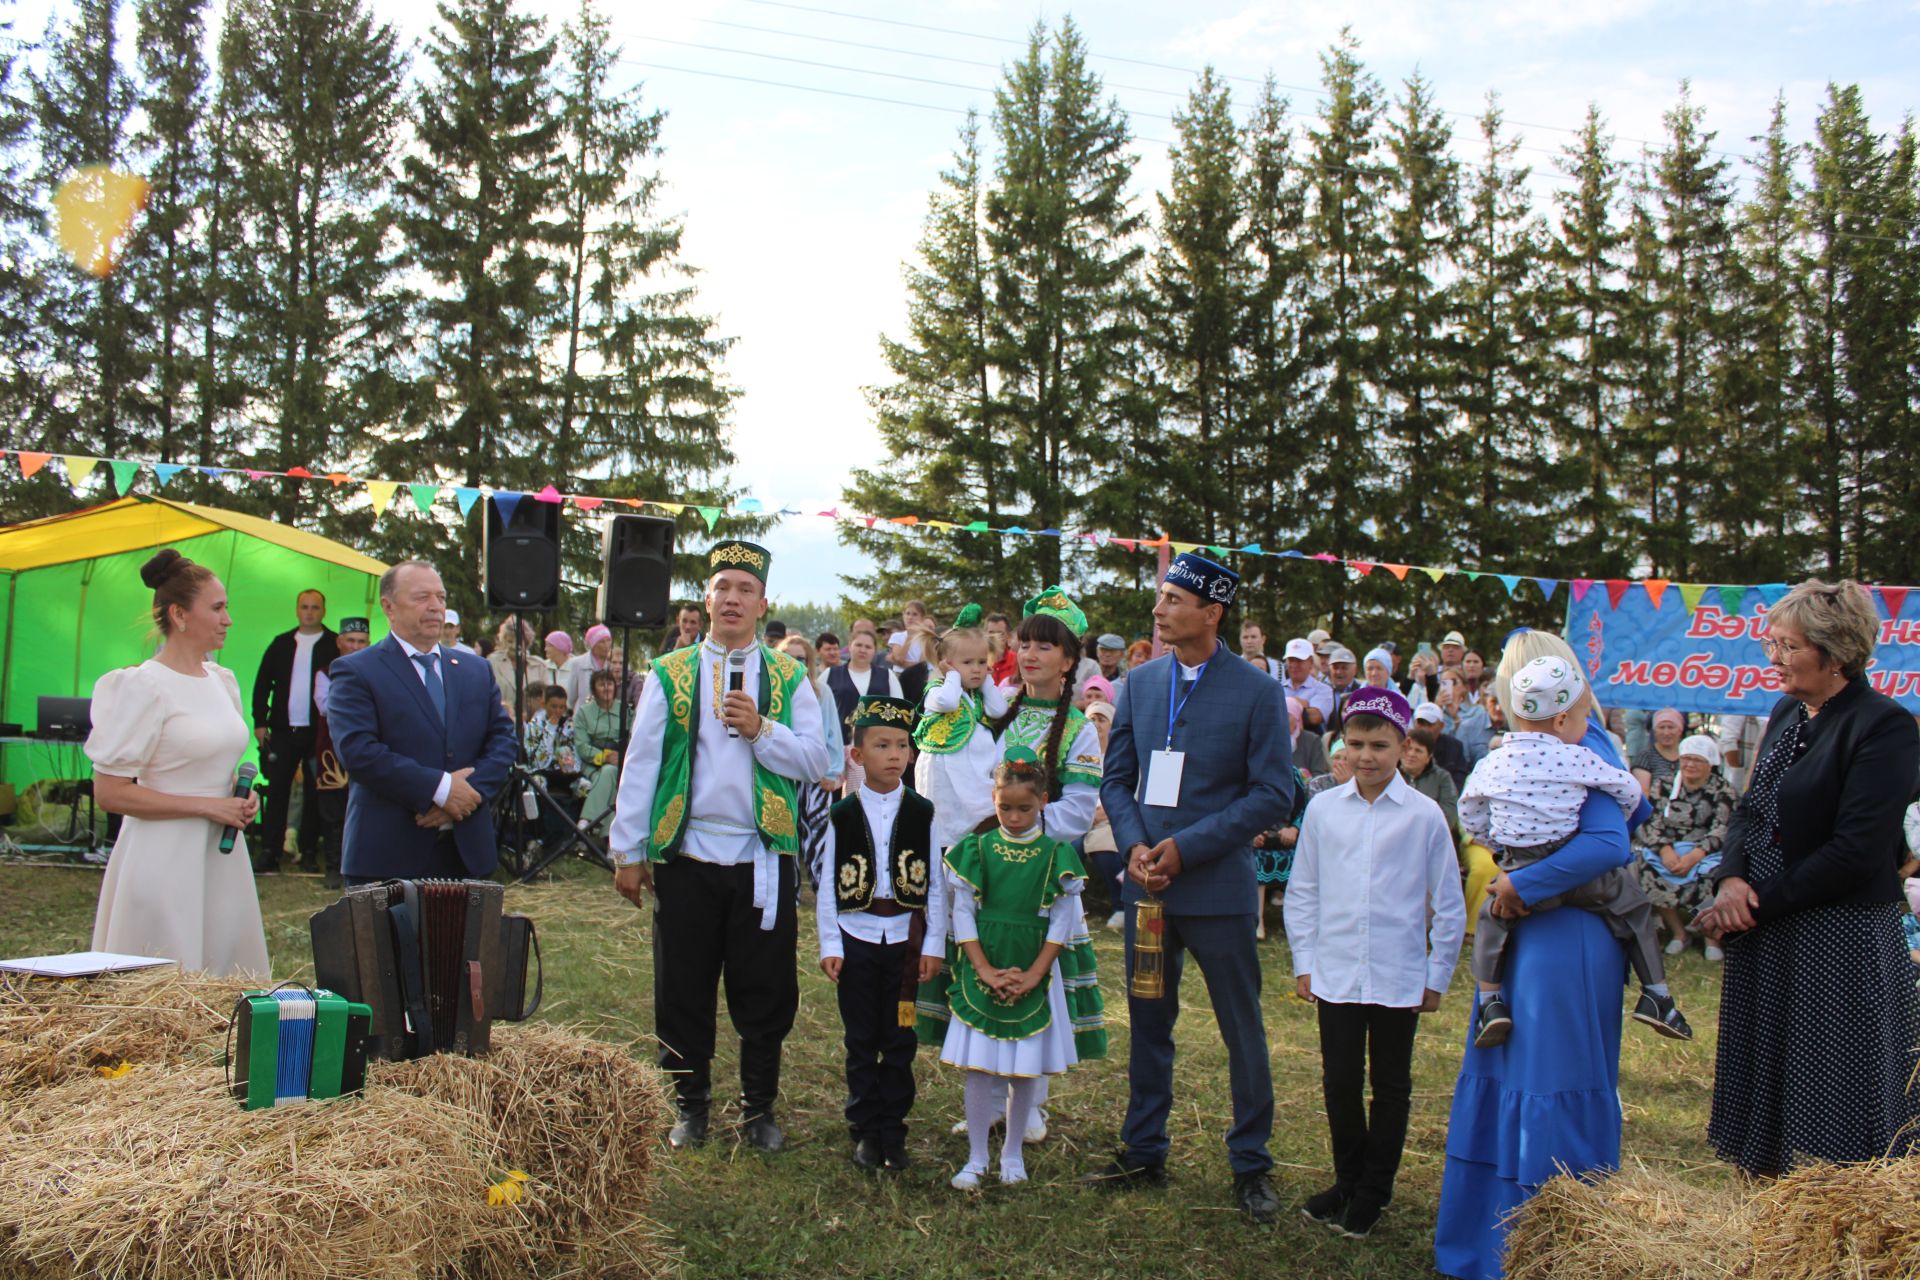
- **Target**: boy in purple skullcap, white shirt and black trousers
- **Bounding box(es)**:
[1286,689,1467,1240]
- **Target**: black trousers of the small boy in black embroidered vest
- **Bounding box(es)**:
[837,931,920,1146]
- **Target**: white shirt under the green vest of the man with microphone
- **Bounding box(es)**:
[607,639,831,929]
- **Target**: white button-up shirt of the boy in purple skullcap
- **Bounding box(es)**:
[1286,771,1467,1009]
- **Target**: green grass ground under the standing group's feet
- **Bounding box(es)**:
[0,864,1730,1280]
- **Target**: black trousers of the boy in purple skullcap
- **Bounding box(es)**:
[1317,1000,1421,1205]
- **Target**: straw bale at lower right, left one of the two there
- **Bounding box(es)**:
[1505,1167,1772,1280]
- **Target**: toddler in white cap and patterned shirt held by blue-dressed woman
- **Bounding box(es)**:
[1459,658,1693,1048]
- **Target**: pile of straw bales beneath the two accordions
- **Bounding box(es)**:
[0,975,672,1280]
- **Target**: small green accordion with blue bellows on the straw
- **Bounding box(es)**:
[227,986,372,1111]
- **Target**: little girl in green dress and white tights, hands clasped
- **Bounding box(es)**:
[941,752,1106,1190]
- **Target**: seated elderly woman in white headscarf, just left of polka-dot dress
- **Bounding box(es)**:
[1634,733,1740,960]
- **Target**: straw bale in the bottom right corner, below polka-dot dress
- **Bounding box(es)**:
[1753,1157,1920,1280]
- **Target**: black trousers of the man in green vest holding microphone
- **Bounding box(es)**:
[653,854,801,1117]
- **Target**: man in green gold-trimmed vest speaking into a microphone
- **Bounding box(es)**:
[609,539,829,1151]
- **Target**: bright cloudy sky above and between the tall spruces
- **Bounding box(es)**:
[21,0,1920,601]
